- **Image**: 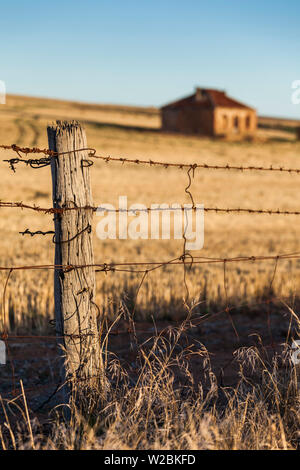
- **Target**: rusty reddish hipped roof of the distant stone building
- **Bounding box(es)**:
[161,88,253,109]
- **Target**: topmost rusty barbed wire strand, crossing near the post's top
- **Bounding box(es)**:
[0,144,300,174]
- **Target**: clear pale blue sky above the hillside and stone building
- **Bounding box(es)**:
[0,0,300,118]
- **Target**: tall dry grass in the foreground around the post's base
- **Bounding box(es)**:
[0,314,300,450]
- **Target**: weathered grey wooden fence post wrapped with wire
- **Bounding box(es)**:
[47,121,103,394]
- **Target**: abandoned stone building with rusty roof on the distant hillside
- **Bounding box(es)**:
[161,88,257,136]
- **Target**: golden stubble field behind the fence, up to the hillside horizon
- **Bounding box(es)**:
[0,96,300,328]
